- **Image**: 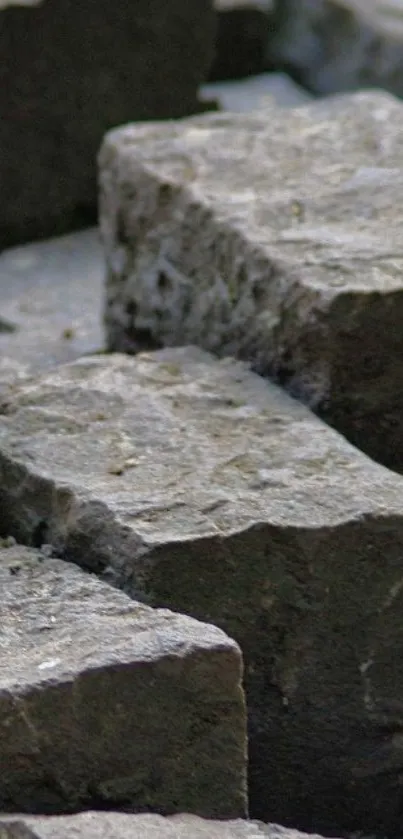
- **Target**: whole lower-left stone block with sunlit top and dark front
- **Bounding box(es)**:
[0,540,247,816]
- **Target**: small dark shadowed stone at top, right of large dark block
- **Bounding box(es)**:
[209,0,272,81]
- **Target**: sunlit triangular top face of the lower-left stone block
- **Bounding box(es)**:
[0,545,236,690]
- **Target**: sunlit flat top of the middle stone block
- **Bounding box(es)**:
[0,347,403,544]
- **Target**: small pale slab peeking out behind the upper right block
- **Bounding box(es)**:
[201,73,312,112]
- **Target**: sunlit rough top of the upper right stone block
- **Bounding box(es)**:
[99,92,403,298]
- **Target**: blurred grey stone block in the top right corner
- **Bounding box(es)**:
[268,0,403,96]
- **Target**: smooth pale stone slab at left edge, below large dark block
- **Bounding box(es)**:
[0,229,104,374]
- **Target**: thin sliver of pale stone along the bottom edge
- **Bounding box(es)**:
[0,811,334,839]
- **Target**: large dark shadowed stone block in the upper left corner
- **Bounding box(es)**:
[0,0,216,248]
